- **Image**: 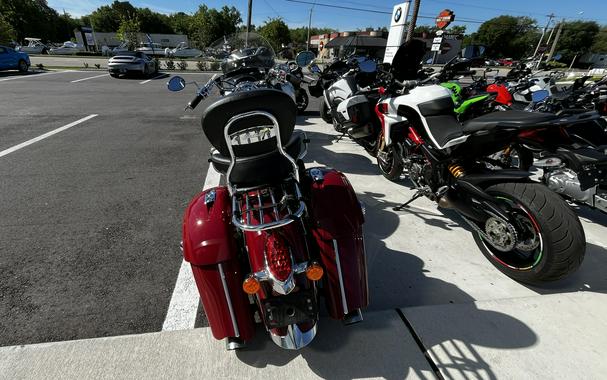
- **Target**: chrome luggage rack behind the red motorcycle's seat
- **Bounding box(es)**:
[232,181,306,231]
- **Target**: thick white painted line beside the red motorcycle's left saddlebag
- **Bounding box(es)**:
[162,165,221,331]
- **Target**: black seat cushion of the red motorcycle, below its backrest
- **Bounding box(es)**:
[209,130,306,187]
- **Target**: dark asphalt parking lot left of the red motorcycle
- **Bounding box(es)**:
[0,72,216,346]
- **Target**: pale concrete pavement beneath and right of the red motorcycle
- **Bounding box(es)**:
[0,116,607,379]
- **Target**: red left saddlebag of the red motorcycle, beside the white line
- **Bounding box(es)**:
[183,187,254,340]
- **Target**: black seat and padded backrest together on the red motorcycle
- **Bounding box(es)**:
[202,89,305,188]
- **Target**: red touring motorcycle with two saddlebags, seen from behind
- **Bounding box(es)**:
[168,75,368,350]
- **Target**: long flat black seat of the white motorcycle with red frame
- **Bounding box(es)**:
[462,111,559,134]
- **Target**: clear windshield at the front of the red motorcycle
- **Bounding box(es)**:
[206,32,275,74]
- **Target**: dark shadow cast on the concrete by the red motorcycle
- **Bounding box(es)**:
[236,162,537,379]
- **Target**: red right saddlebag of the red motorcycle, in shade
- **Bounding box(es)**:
[308,168,369,319]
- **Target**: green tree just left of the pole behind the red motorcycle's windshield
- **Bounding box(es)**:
[190,5,242,46]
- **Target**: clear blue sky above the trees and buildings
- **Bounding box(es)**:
[47,0,607,32]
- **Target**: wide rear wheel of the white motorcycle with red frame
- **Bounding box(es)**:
[475,183,586,285]
